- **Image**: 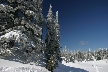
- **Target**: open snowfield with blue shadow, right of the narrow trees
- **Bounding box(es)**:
[55,60,108,72]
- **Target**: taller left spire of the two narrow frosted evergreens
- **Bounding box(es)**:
[45,5,54,62]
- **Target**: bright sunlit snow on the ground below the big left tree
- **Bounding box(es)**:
[0,59,48,72]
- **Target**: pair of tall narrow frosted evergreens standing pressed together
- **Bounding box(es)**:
[45,5,61,71]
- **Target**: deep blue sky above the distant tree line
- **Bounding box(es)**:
[43,0,108,50]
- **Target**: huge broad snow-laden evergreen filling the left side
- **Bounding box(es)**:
[0,0,44,64]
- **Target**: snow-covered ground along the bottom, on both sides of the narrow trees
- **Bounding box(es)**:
[0,59,108,72]
